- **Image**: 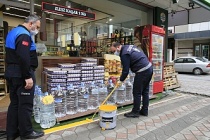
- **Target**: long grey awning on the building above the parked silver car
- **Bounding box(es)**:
[174,31,210,40]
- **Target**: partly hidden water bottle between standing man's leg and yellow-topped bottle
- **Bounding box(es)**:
[33,86,42,123]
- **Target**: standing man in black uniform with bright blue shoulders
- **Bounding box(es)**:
[5,15,44,140]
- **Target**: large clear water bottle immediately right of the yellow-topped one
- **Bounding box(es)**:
[54,85,66,118]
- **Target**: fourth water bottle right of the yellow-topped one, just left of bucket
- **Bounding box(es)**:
[88,82,99,109]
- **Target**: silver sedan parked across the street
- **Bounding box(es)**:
[174,56,210,75]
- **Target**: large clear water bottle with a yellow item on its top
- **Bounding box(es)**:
[40,93,56,128]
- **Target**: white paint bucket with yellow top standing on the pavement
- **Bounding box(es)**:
[99,105,117,130]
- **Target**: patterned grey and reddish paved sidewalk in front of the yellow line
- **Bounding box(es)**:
[34,94,210,140]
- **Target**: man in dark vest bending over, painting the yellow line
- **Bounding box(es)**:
[110,42,153,118]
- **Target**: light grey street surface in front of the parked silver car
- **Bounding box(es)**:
[176,73,210,96]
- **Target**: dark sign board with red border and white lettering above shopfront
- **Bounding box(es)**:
[42,2,95,20]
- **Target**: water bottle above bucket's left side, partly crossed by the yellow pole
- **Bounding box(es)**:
[98,82,108,104]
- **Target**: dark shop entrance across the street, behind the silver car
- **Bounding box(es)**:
[194,44,210,59]
